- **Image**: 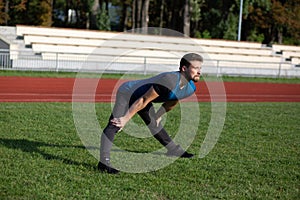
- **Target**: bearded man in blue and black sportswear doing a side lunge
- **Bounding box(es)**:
[98,53,203,174]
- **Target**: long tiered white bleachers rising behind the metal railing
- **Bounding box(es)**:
[0,25,300,76]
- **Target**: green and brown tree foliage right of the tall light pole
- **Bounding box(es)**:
[243,0,300,44]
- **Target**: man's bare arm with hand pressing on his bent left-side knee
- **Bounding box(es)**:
[111,87,159,128]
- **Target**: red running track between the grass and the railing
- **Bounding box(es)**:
[0,77,300,102]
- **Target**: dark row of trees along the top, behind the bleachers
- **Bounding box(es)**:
[0,0,300,45]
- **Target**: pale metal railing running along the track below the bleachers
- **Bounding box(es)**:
[0,49,300,77]
